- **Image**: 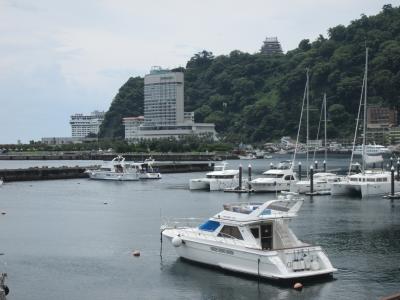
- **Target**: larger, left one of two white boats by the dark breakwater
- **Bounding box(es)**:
[86,156,140,181]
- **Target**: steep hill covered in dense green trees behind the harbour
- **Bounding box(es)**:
[100,5,400,142]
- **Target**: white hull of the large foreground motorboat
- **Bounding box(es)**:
[163,230,336,280]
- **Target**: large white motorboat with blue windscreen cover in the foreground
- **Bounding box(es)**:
[161,195,337,280]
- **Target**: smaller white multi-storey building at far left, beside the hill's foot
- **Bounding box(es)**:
[69,110,105,137]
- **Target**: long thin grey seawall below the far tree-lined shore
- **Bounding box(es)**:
[0,152,237,161]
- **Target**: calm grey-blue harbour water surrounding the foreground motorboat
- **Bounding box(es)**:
[0,157,400,300]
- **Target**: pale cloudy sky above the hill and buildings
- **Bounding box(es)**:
[0,0,400,144]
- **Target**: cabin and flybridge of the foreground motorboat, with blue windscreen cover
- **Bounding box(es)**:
[198,200,305,251]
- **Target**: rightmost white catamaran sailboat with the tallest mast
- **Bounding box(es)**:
[331,48,400,198]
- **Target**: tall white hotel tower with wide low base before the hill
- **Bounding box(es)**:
[123,67,216,140]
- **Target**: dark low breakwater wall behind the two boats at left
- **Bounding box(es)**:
[0,162,214,182]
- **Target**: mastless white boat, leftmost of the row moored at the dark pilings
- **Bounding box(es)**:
[189,162,239,191]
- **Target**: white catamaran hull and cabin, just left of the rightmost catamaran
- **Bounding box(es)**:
[290,172,343,194]
